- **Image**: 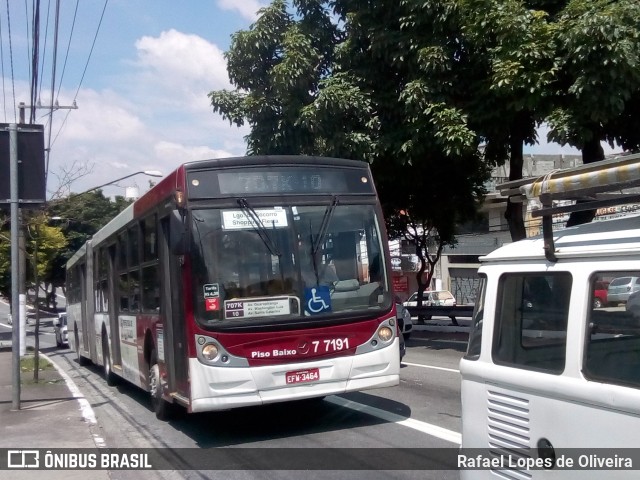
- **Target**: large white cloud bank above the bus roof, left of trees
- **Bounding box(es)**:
[43,30,248,195]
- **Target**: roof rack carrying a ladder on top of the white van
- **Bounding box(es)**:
[496,153,640,263]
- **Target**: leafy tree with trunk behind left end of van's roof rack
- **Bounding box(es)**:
[460,0,559,241]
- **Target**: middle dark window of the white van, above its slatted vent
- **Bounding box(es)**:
[492,273,572,374]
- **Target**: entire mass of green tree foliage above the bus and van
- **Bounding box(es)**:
[210,0,640,245]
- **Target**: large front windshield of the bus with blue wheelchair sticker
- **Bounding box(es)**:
[190,201,391,326]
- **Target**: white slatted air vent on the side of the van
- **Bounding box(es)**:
[487,390,535,480]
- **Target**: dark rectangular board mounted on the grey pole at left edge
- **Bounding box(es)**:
[0,123,46,208]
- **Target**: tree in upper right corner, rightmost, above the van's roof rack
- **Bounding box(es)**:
[547,0,640,226]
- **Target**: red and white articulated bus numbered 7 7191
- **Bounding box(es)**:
[67,156,400,418]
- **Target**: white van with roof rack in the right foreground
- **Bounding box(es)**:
[459,155,640,479]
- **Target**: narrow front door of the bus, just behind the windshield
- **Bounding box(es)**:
[158,213,188,392]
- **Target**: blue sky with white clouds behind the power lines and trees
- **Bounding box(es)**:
[0,0,616,197]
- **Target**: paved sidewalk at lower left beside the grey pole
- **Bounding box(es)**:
[0,332,110,480]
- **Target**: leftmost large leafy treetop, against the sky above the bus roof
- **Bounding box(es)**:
[209,0,338,155]
